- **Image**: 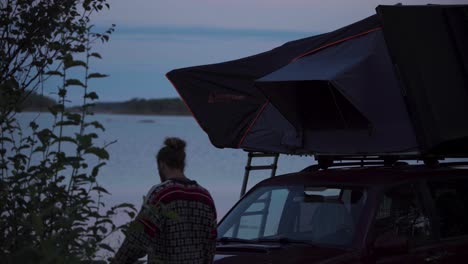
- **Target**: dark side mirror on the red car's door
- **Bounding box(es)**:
[374,232,409,255]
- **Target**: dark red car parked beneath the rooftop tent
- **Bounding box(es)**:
[214,165,468,264]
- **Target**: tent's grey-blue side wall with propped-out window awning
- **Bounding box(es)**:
[256,29,418,155]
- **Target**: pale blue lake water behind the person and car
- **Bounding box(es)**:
[18,113,314,223]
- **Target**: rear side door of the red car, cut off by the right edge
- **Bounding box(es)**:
[427,177,468,263]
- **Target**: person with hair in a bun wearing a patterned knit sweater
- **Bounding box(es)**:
[111,138,217,264]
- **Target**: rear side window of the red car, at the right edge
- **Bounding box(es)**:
[429,179,468,238]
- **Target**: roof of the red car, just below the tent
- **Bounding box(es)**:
[259,165,468,186]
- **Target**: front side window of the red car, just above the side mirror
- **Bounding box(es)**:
[374,184,431,243]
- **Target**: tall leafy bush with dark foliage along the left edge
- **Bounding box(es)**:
[0,0,135,263]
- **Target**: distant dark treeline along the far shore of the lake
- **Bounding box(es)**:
[22,93,190,115]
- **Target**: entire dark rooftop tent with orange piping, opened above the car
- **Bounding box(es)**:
[167,5,468,156]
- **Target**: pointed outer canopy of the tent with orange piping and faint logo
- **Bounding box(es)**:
[167,15,380,153]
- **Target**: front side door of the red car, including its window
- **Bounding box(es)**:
[371,182,437,264]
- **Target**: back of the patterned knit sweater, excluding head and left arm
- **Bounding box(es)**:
[141,180,216,263]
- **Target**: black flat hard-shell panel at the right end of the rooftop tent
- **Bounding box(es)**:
[377,5,468,156]
